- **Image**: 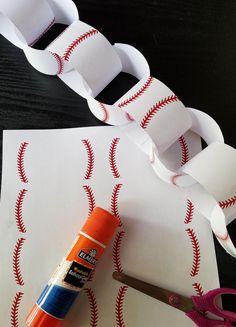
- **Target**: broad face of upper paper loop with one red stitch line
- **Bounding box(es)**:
[46,20,122,97]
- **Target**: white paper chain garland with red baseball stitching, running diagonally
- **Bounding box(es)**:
[0,0,236,257]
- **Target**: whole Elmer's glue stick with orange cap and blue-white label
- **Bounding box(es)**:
[26,208,119,327]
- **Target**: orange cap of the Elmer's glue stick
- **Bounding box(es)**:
[81,208,120,246]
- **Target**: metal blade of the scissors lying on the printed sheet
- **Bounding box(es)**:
[112,272,193,312]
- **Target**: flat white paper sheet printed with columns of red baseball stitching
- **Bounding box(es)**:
[0,127,219,327]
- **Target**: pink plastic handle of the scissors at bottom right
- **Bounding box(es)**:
[186,288,236,327]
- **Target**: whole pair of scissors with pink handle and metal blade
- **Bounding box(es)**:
[112,272,236,327]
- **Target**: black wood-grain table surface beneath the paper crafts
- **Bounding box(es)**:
[0,0,236,309]
